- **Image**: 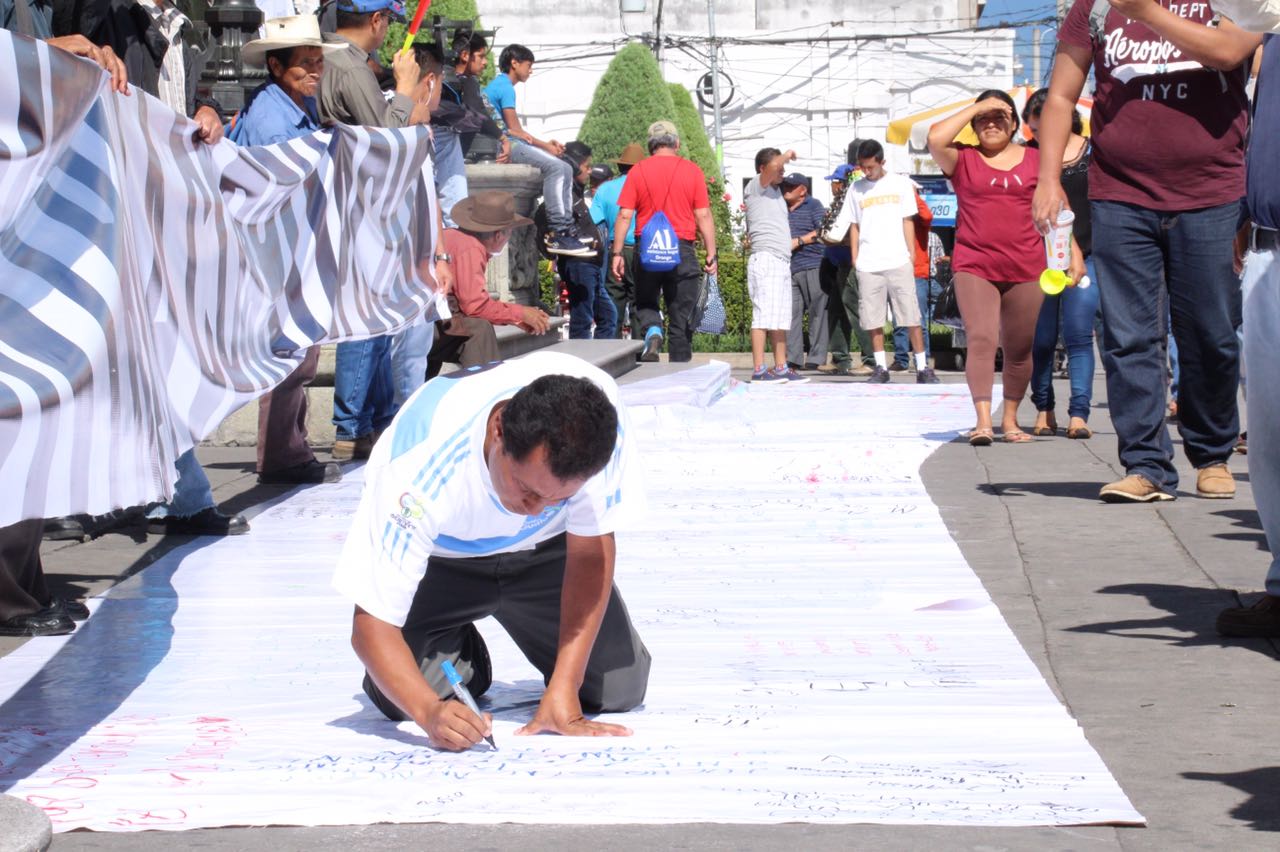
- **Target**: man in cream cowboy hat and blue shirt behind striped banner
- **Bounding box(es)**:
[227,15,342,485]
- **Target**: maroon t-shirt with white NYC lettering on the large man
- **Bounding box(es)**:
[1057,0,1249,212]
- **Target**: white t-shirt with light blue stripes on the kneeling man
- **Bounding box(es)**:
[333,353,645,627]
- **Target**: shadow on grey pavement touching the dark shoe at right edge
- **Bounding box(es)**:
[1066,583,1276,658]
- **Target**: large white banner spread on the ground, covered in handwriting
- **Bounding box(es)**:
[0,384,1142,832]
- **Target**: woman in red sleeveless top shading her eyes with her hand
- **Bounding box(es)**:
[929,90,1080,446]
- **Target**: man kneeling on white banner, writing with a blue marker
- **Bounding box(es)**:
[334,353,649,750]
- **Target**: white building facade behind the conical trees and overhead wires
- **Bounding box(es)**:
[480,0,1014,206]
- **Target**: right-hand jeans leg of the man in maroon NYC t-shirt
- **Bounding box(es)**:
[1165,203,1240,469]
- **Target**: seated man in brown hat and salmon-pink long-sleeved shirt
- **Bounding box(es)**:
[426,189,550,377]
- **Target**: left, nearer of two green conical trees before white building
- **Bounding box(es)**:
[577,42,680,160]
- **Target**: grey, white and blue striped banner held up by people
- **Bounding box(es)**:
[0,29,438,526]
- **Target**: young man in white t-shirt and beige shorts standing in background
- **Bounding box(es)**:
[841,139,938,385]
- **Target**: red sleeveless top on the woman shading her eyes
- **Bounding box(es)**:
[951,145,1044,281]
